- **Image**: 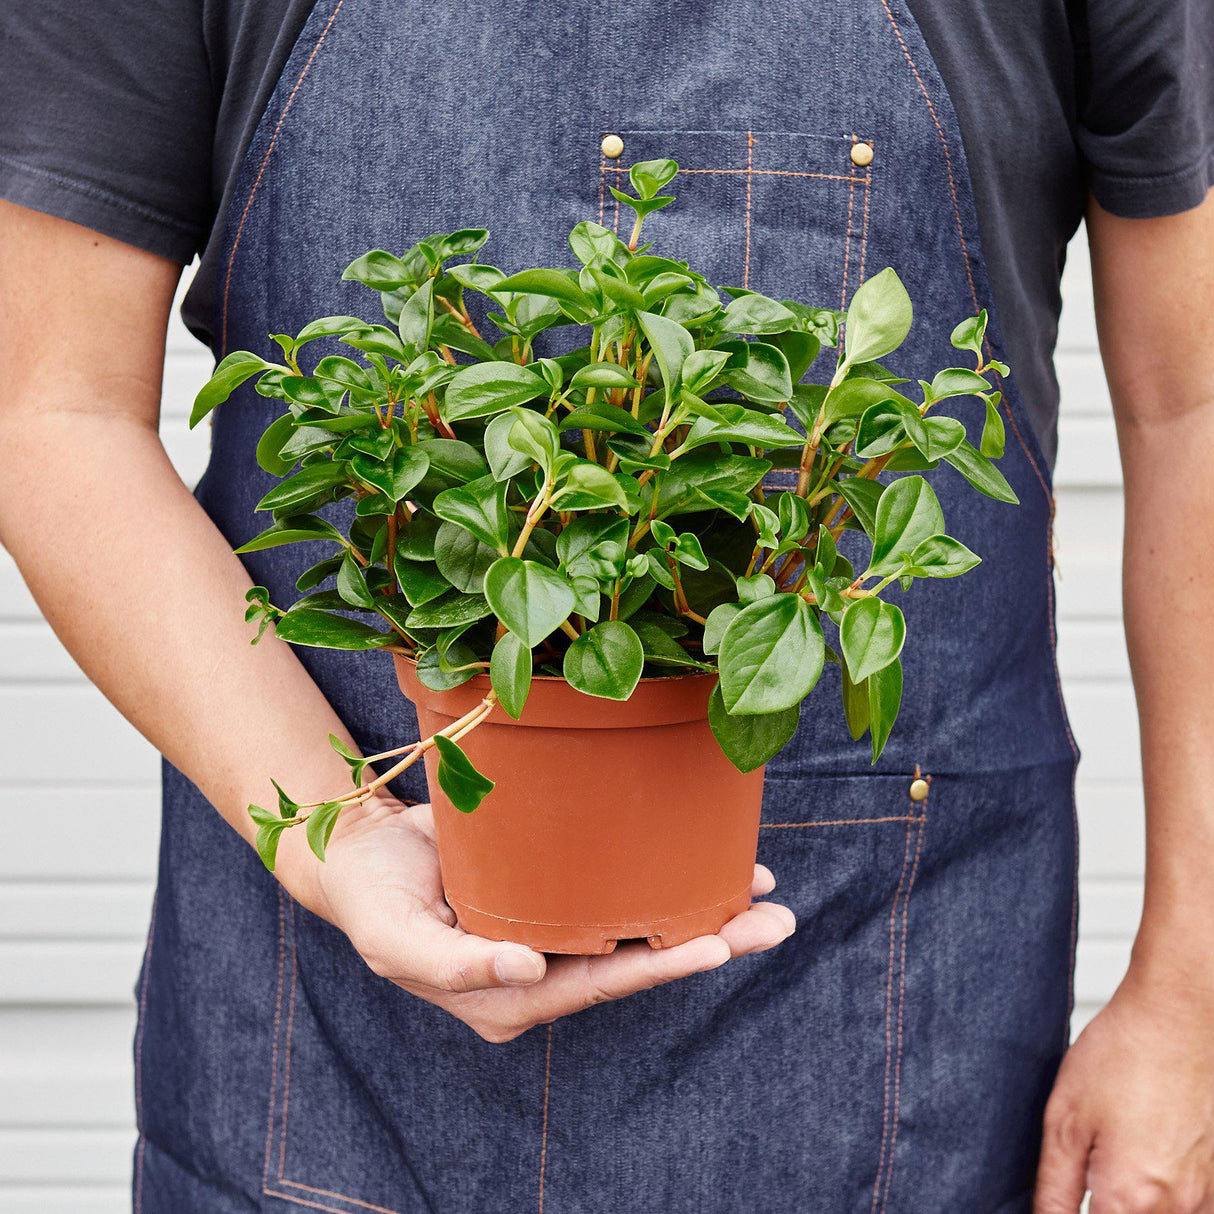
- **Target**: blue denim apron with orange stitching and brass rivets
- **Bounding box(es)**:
[135,0,1077,1214]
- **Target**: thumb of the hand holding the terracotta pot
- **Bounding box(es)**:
[363,915,548,994]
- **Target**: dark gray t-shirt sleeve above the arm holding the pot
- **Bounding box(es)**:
[0,0,215,263]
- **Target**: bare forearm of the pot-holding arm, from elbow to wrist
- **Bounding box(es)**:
[0,409,350,903]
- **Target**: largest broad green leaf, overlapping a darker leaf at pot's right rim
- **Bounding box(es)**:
[717,594,826,716]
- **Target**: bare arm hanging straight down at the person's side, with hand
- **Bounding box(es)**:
[1037,195,1214,1214]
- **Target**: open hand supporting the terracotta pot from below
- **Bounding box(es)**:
[278,799,795,1043]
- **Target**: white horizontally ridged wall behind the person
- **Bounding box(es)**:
[0,239,1142,1214]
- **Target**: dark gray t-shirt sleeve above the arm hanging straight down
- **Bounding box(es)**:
[1077,0,1214,219]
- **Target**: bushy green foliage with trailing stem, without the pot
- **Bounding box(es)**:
[191,160,1016,867]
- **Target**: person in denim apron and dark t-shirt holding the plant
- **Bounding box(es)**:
[0,0,1214,1214]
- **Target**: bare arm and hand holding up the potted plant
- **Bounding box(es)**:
[0,203,793,1040]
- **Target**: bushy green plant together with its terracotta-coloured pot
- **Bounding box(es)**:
[192,160,1016,952]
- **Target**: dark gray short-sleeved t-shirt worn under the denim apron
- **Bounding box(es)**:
[0,0,1214,459]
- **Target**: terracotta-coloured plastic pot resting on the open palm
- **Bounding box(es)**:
[396,657,764,953]
